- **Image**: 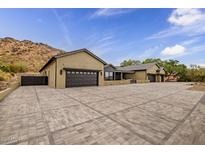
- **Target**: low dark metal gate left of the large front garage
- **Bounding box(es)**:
[21,76,48,86]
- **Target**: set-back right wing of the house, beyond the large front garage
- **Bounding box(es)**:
[104,63,165,82]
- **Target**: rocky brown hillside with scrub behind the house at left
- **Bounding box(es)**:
[0,37,64,72]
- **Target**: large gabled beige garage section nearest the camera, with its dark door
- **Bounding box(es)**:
[40,49,107,88]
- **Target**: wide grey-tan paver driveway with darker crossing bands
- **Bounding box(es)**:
[0,83,205,144]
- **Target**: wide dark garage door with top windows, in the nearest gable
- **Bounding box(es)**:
[66,70,98,87]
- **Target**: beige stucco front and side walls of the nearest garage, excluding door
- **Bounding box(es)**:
[41,52,104,88]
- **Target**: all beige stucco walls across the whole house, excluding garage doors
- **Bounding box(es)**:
[41,50,165,88]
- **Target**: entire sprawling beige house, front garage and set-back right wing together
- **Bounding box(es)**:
[40,49,165,88]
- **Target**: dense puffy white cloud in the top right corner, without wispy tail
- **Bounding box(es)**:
[168,9,205,26]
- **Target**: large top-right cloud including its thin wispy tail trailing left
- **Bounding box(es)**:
[146,9,205,40]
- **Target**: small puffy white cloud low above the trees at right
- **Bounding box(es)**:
[161,44,186,56]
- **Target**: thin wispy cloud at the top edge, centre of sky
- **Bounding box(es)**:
[91,8,135,18]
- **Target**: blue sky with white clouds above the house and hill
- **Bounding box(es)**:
[0,8,205,66]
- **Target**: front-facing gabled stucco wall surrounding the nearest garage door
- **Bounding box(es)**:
[56,52,104,88]
